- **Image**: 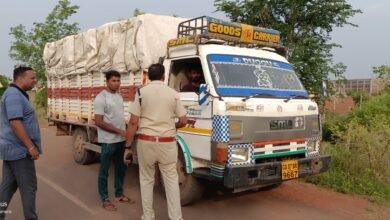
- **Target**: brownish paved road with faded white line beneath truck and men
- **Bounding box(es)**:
[0,128,390,220]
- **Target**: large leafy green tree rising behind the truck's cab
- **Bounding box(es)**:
[214,0,361,101]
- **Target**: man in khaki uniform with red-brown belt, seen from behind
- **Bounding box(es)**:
[124,64,187,220]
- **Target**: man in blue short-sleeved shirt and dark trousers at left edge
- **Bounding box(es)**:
[0,67,42,219]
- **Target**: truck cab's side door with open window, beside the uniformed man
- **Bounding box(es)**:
[168,57,212,160]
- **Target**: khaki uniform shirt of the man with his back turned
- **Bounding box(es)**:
[130,80,186,137]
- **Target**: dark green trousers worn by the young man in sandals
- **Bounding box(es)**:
[98,142,126,202]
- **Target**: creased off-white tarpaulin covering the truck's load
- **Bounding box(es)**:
[43,14,186,77]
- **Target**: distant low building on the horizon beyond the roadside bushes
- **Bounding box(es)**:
[332,79,384,95]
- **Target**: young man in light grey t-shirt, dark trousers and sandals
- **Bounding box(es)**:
[94,70,133,211]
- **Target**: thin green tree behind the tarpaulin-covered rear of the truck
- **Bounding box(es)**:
[9,0,79,107]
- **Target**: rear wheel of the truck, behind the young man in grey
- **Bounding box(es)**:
[72,128,95,165]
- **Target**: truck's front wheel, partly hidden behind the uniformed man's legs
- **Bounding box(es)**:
[159,150,204,206]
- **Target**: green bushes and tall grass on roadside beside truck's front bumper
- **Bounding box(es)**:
[307,94,390,202]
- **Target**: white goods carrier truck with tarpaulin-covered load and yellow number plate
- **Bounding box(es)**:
[43,14,331,205]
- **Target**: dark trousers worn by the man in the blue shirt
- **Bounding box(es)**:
[0,158,38,219]
